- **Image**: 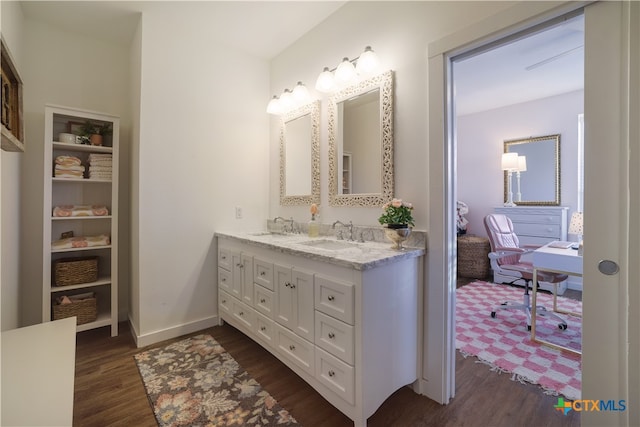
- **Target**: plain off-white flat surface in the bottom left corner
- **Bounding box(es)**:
[0,317,76,426]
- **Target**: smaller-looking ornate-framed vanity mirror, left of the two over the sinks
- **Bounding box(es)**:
[280,101,320,206]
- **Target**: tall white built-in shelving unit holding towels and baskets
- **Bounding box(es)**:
[42,105,120,336]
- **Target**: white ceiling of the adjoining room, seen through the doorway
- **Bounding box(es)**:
[453,15,584,115]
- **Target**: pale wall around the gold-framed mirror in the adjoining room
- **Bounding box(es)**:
[457,91,584,236]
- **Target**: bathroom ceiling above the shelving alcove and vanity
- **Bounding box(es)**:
[21,1,346,60]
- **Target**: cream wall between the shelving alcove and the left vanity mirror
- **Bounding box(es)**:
[134,3,269,345]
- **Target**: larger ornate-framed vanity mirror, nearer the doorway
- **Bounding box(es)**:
[329,71,393,207]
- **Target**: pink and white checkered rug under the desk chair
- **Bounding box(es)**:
[456,282,582,400]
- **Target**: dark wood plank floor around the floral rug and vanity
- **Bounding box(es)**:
[74,312,580,427]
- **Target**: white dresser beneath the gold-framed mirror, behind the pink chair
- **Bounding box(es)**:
[494,206,569,246]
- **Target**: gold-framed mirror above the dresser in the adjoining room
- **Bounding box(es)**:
[504,134,560,206]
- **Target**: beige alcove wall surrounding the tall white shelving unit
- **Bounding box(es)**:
[20,19,131,325]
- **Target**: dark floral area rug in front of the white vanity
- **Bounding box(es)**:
[134,335,298,427]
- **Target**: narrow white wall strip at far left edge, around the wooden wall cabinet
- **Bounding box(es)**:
[0,2,28,331]
